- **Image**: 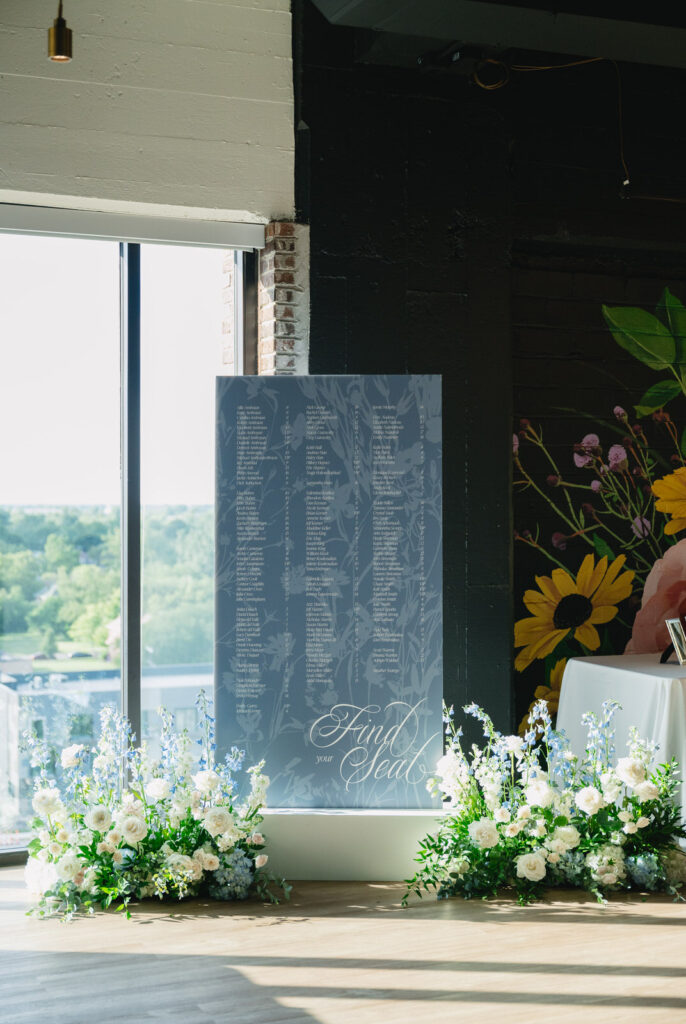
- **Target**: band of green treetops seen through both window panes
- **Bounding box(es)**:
[0,507,214,667]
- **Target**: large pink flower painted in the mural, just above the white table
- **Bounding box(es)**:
[626,540,686,654]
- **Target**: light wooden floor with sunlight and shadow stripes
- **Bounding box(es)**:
[0,867,686,1024]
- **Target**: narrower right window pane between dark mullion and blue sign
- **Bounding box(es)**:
[140,246,223,761]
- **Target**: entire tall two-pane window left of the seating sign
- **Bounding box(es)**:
[0,234,247,855]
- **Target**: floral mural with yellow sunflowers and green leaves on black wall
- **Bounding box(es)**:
[513,289,686,731]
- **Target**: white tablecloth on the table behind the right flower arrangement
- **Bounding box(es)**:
[557,654,686,814]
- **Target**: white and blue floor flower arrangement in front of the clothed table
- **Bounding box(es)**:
[403,700,686,904]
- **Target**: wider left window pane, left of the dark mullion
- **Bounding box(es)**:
[0,234,121,850]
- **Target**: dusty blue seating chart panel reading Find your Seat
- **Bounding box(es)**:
[216,376,442,808]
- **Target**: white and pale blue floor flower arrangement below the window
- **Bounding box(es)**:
[25,691,291,919]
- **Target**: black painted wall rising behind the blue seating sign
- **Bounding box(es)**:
[294,0,686,728]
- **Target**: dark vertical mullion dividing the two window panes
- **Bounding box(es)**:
[120,243,141,741]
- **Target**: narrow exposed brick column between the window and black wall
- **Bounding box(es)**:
[258,221,309,374]
